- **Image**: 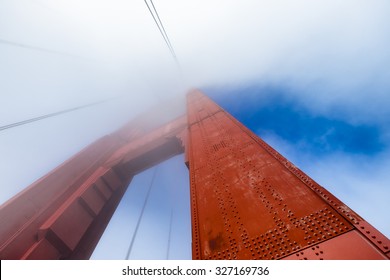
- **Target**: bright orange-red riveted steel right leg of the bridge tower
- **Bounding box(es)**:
[187,92,389,259]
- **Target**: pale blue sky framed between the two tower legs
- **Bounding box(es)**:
[92,155,191,259]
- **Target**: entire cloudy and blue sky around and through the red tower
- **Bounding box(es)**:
[0,0,390,259]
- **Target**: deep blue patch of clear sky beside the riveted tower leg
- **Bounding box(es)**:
[206,84,386,156]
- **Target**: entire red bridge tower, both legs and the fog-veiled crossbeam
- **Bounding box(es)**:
[0,91,390,259]
